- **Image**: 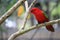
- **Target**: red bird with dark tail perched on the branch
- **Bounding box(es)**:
[30,7,54,32]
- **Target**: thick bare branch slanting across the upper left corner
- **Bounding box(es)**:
[0,0,25,25]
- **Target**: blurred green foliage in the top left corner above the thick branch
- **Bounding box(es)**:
[0,0,17,14]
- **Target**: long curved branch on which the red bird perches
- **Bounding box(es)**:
[8,19,60,40]
